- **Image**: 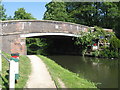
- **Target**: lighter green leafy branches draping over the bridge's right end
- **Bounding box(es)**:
[76,26,107,55]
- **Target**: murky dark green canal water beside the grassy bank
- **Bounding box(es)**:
[49,55,118,88]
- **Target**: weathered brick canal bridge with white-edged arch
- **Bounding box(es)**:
[0,20,111,55]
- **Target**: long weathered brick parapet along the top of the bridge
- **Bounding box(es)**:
[2,20,89,35]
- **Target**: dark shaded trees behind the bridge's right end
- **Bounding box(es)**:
[66,2,120,37]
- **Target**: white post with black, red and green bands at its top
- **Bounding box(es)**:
[9,53,19,90]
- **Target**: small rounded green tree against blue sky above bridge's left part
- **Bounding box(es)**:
[14,8,35,20]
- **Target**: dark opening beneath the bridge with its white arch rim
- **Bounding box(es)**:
[25,33,80,55]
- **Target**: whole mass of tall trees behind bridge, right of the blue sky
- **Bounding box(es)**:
[43,1,120,38]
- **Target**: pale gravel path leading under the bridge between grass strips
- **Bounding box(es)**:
[26,55,56,88]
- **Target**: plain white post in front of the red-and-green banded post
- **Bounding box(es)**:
[9,60,15,90]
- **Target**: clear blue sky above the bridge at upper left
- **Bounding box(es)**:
[2,2,49,20]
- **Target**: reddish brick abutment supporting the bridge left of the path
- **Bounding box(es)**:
[2,35,27,55]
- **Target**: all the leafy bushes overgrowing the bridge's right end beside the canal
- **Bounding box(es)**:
[76,26,120,58]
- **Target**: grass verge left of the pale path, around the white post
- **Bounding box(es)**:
[1,53,31,88]
